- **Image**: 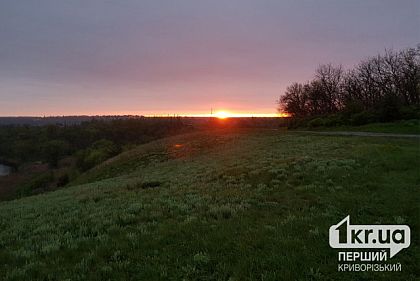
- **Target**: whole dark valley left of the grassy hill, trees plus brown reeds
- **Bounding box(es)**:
[0,117,193,198]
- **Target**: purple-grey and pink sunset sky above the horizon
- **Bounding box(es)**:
[0,0,420,116]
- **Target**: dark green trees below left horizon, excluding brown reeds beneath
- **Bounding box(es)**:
[0,118,191,170]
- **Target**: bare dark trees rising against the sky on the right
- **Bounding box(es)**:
[278,44,420,123]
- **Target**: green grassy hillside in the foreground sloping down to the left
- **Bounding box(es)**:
[0,130,420,281]
